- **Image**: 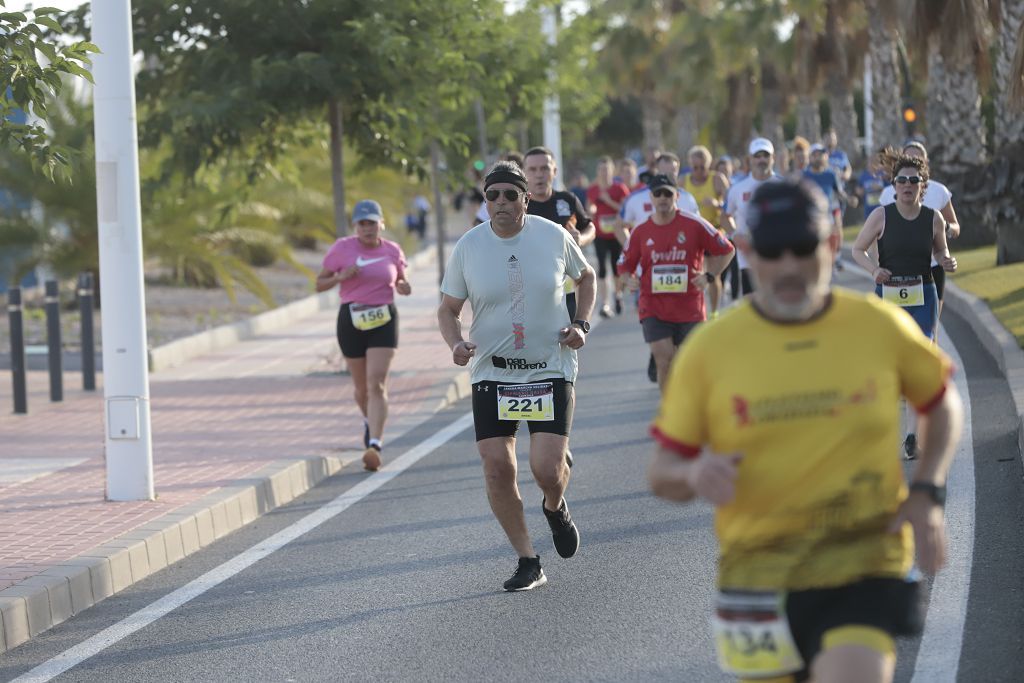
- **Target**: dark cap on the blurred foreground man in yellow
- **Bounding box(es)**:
[746,180,831,249]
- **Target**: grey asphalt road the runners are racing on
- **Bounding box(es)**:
[0,270,1024,681]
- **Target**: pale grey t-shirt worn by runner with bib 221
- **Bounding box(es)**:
[441,215,587,383]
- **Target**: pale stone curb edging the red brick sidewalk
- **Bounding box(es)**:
[0,362,471,653]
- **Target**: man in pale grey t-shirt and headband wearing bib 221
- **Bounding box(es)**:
[437,162,596,591]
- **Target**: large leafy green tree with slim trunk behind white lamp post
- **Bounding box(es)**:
[62,0,515,240]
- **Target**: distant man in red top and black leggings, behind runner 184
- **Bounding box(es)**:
[587,157,630,317]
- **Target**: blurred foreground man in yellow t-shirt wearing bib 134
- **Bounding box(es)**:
[648,181,963,682]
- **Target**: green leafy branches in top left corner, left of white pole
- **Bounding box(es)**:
[0,0,98,179]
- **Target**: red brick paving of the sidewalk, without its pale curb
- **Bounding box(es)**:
[0,246,464,652]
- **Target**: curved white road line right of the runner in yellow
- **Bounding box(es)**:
[910,329,975,683]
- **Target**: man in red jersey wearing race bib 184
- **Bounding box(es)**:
[618,175,733,387]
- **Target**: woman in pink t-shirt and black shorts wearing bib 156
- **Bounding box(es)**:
[316,200,413,471]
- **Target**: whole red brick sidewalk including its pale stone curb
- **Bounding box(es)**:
[0,246,469,652]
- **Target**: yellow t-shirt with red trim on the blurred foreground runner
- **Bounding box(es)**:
[652,289,951,590]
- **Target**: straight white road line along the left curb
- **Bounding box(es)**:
[12,413,473,683]
